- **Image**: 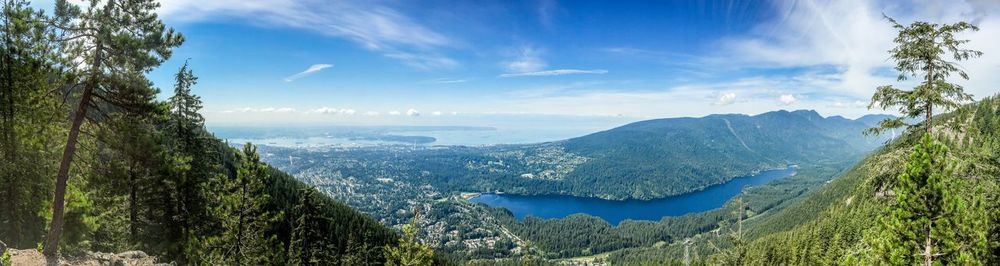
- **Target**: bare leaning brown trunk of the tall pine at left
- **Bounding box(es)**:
[42,84,92,257]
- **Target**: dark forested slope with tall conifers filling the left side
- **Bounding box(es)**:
[0,0,442,265]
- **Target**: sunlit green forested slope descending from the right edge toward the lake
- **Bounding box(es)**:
[608,96,1000,265]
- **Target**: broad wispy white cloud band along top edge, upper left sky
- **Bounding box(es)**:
[157,0,458,68]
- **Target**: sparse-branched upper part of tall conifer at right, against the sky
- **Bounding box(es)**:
[865,16,983,134]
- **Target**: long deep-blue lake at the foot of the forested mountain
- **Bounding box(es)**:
[470,166,795,224]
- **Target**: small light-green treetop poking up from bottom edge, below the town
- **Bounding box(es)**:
[384,215,434,266]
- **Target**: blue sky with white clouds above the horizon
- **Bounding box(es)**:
[34,0,1000,125]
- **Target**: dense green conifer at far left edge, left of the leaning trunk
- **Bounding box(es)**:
[0,0,64,248]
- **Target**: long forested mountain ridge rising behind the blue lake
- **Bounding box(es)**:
[559,110,884,199]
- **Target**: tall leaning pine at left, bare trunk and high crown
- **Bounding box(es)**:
[43,0,183,256]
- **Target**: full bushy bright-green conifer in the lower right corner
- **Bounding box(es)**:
[873,135,989,265]
